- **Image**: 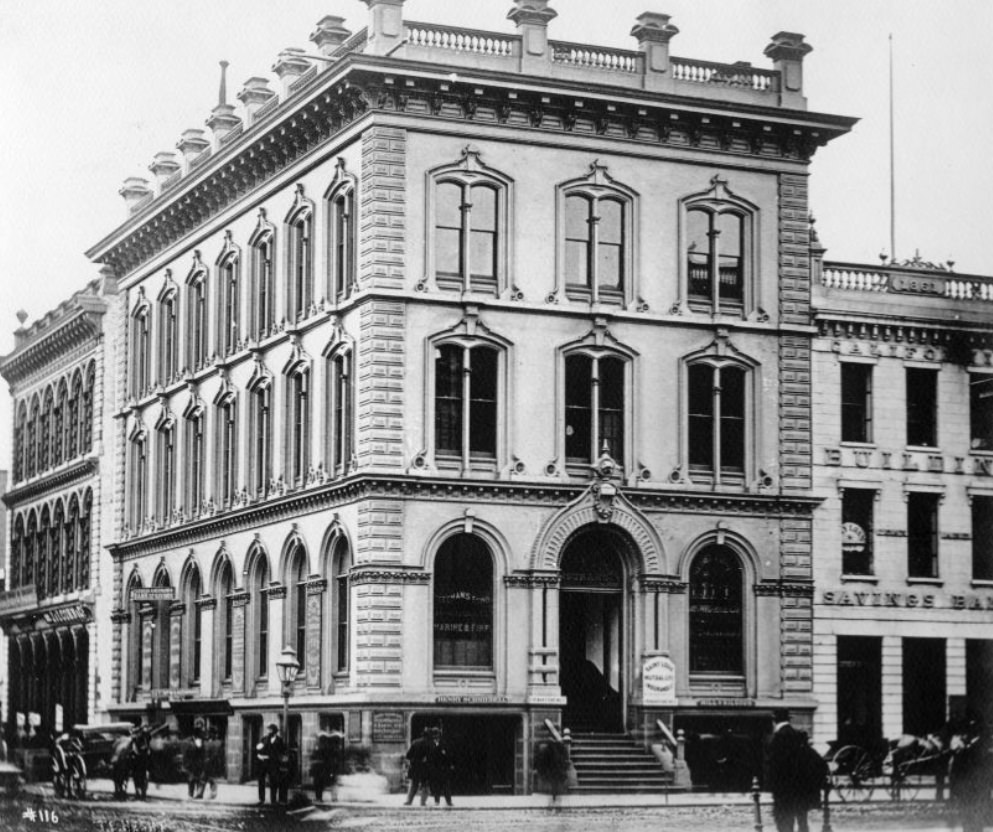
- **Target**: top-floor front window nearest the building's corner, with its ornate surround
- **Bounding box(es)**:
[428,146,513,294]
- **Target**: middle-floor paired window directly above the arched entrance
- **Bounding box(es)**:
[565,352,628,465]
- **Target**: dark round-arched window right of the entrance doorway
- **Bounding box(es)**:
[689,545,744,675]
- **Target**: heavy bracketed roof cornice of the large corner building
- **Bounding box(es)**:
[86,54,855,276]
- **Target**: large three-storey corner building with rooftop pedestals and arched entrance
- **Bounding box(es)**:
[88,0,853,793]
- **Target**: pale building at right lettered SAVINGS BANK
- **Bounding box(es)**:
[813,242,993,745]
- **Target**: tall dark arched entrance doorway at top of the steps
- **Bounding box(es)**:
[559,528,625,731]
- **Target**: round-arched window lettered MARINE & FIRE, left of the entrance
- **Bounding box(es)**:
[434,534,493,668]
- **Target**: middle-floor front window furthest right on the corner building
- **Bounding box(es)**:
[687,360,748,482]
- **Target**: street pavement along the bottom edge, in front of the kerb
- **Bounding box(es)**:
[0,797,956,832]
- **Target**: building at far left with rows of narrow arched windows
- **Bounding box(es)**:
[0,274,117,744]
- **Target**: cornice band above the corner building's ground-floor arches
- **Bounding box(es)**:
[108,473,821,560]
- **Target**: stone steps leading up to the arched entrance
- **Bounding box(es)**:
[572,731,672,794]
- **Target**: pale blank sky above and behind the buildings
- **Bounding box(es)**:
[0,0,993,468]
